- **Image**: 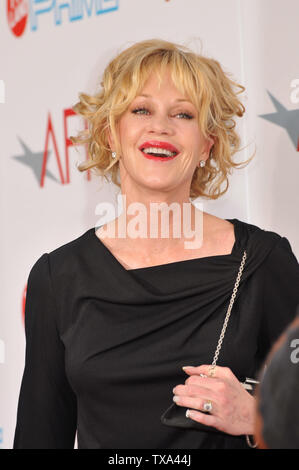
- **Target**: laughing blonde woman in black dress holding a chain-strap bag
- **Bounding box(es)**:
[14,40,299,449]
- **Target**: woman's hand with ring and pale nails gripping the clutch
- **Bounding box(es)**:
[173,365,255,436]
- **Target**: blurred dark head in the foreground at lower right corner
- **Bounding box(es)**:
[255,307,299,449]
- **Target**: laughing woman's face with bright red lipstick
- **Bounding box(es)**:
[109,70,213,194]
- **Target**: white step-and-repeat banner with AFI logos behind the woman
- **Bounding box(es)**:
[0,0,299,448]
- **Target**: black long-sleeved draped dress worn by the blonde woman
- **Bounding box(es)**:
[14,219,299,449]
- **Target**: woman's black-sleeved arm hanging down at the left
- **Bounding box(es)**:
[14,253,77,449]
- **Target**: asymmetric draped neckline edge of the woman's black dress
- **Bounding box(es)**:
[89,219,240,272]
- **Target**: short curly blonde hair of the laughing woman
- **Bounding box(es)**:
[70,39,254,199]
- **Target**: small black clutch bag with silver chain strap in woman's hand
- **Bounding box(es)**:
[161,251,258,434]
